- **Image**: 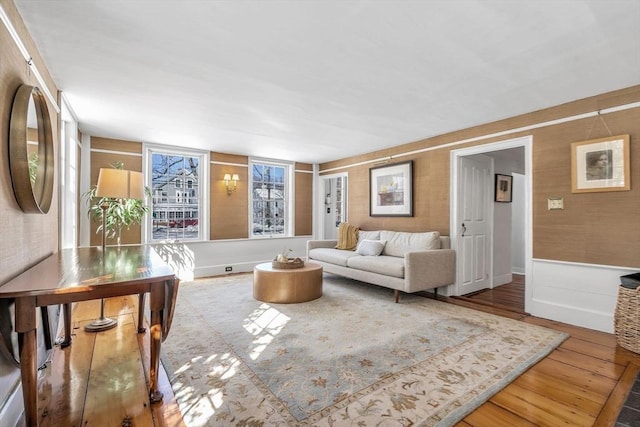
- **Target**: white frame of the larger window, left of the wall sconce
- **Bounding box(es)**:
[142,143,210,244]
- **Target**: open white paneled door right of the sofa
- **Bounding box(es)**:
[457,155,493,295]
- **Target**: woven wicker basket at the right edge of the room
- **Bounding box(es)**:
[615,286,640,353]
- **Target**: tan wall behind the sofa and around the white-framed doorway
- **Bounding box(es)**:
[320,86,640,267]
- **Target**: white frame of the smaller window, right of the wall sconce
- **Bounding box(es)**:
[247,157,295,239]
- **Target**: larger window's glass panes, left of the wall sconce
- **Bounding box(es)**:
[145,148,208,241]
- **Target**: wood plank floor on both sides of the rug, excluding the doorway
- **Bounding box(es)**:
[25,280,640,427]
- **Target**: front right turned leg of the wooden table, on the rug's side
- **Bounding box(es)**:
[149,282,165,403]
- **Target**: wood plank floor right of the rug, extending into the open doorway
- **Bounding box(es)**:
[450,275,640,427]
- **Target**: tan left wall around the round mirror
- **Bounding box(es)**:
[0,0,60,413]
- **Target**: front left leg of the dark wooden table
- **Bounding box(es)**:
[15,297,38,427]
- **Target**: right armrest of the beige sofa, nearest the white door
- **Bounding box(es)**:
[404,249,456,292]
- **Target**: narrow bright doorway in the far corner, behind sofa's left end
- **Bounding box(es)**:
[319,173,348,240]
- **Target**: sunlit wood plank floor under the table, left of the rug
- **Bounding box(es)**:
[30,296,184,427]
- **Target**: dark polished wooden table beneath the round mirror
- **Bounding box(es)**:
[0,246,179,426]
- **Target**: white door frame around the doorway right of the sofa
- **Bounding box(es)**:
[449,135,533,312]
